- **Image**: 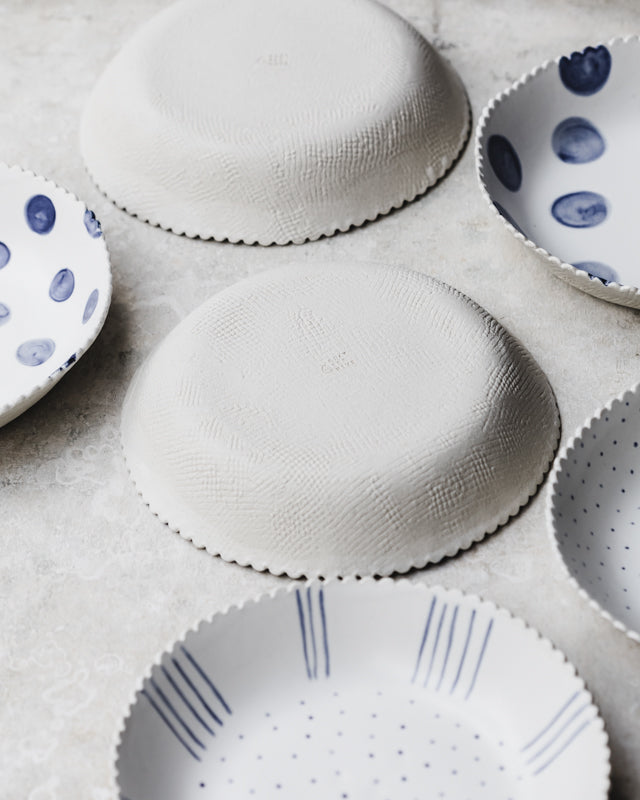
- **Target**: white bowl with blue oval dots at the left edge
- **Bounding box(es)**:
[0,159,111,425]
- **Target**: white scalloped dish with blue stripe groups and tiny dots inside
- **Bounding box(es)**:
[116,580,609,800]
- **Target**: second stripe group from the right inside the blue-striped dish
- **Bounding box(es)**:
[411,595,493,700]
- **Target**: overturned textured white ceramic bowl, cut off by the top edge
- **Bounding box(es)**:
[81,0,469,244]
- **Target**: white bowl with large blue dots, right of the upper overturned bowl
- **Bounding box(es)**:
[476,37,640,308]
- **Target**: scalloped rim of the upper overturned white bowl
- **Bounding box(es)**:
[81,70,472,247]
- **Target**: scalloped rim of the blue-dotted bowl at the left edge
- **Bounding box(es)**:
[0,161,113,428]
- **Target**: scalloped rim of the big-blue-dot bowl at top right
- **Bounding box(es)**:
[474,34,640,308]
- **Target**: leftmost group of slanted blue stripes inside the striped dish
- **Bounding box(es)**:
[141,646,232,761]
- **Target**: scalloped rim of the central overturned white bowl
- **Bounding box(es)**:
[120,276,561,580]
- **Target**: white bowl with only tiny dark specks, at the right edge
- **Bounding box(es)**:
[547,384,640,642]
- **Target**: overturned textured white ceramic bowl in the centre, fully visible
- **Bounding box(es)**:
[122,263,559,576]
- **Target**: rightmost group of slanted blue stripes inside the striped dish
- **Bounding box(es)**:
[521,692,593,775]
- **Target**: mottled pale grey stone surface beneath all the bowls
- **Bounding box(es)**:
[0,0,640,800]
